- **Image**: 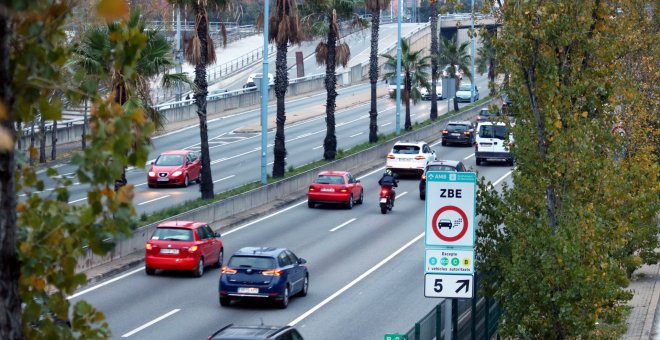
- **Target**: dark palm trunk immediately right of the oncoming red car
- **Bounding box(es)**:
[193,2,215,200]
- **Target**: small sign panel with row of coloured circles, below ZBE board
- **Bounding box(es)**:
[424,248,474,274]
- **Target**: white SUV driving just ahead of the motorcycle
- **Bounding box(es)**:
[385,141,436,176]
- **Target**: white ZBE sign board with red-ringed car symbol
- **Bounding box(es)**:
[424,171,477,248]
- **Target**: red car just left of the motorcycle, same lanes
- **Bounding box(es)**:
[307,171,364,209]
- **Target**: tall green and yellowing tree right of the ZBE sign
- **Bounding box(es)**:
[477,0,660,339]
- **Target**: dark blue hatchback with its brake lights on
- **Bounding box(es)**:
[218,247,309,308]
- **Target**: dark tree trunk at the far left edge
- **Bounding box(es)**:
[0,6,23,340]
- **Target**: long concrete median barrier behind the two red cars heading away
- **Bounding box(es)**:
[76,102,490,271]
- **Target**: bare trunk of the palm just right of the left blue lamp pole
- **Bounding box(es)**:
[272,41,289,178]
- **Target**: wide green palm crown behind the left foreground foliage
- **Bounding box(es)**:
[70,12,189,190]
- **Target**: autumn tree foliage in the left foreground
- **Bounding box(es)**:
[0,0,154,339]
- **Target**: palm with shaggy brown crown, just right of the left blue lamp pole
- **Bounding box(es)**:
[258,0,304,178]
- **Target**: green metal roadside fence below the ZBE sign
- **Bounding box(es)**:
[398,273,501,340]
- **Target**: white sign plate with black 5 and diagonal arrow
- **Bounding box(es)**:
[424,274,474,299]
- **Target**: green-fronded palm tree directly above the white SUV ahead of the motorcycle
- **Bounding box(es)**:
[381,39,431,130]
